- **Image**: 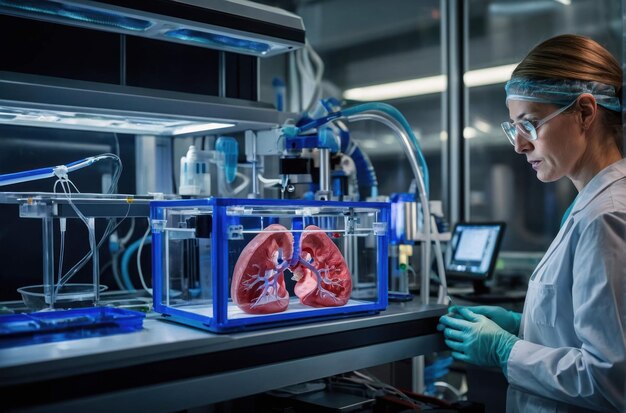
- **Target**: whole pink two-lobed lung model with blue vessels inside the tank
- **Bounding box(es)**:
[230,224,352,314]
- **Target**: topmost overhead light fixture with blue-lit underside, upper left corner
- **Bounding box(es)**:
[0,0,305,57]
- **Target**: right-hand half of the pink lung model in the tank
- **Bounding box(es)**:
[291,225,352,307]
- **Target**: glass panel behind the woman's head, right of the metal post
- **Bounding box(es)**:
[464,0,622,260]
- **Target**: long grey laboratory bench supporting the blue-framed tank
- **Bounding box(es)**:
[0,298,447,413]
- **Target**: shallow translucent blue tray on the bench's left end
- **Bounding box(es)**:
[0,307,146,347]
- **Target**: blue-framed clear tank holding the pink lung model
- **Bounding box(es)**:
[150,198,390,332]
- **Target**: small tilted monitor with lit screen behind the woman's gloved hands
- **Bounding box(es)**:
[446,222,505,280]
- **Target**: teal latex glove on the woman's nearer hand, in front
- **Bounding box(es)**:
[437,307,519,374]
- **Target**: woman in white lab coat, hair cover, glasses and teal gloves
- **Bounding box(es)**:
[439,35,626,412]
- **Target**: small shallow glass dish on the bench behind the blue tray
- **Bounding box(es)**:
[17,284,108,311]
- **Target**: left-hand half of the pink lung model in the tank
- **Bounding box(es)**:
[230,224,293,314]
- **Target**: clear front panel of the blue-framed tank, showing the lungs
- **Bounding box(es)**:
[226,206,378,319]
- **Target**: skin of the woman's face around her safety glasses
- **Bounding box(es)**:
[508,100,586,182]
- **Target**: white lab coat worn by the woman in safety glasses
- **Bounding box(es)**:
[507,159,626,413]
